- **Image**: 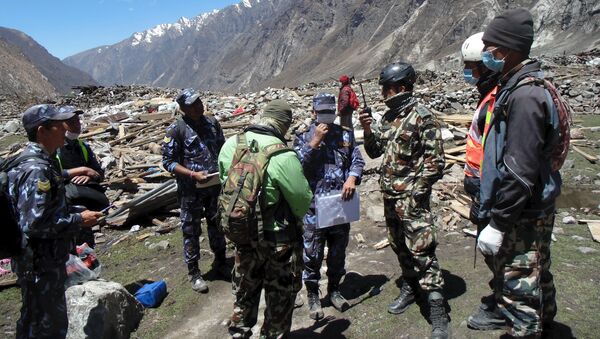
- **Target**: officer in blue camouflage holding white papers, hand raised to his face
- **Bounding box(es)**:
[294,93,365,320]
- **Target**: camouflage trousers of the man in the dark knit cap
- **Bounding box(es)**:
[494,215,556,337]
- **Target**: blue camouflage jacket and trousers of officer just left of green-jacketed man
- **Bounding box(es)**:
[163,116,225,267]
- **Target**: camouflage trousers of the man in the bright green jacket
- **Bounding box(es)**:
[229,241,302,338]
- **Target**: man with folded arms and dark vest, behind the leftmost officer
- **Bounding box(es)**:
[54,106,110,247]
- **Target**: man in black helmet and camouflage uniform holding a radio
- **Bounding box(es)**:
[360,62,448,338]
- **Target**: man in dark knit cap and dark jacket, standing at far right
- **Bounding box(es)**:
[476,8,561,337]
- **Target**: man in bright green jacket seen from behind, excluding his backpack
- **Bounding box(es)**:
[219,100,312,338]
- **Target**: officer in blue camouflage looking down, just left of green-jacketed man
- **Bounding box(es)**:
[163,89,230,292]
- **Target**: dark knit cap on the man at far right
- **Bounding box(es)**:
[481,8,533,54]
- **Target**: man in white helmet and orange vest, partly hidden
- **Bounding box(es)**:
[461,32,506,330]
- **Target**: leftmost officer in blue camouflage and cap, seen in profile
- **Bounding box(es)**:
[8,105,102,338]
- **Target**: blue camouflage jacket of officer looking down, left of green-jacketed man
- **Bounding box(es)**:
[162,116,225,194]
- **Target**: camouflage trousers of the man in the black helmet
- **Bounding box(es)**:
[384,197,444,292]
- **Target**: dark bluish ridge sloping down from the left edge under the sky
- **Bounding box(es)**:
[0,27,97,93]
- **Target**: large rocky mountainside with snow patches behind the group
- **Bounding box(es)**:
[64,0,600,91]
